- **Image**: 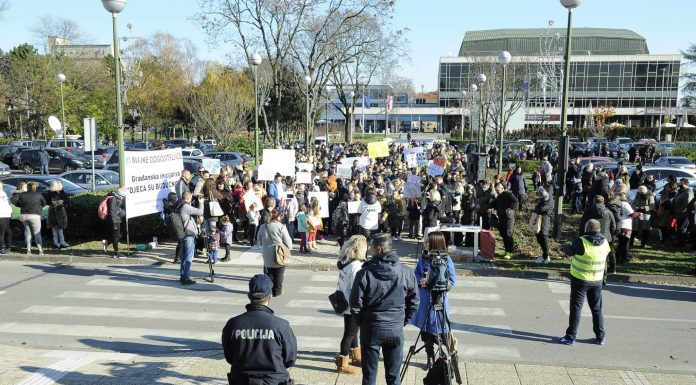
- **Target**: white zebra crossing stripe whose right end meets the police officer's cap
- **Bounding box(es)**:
[56,291,249,306]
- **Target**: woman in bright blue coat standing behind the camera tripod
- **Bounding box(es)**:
[411,231,456,369]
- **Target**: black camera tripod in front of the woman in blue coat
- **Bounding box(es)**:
[400,291,462,385]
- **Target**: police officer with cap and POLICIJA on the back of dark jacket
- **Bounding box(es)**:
[222,274,297,385]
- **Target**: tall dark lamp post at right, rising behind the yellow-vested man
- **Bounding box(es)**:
[554,0,582,239]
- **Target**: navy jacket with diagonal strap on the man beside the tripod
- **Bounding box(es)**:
[350,250,418,329]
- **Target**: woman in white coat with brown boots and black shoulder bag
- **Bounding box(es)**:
[336,235,367,374]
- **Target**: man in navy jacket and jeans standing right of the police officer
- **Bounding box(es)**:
[350,234,418,385]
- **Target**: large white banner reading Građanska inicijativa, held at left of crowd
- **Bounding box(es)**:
[123,148,184,218]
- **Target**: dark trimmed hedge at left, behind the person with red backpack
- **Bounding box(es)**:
[65,190,166,242]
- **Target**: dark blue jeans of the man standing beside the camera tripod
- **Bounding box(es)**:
[360,326,404,385]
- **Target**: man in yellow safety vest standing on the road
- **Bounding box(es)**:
[558,219,609,345]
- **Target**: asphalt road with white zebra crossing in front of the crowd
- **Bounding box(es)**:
[0,262,696,372]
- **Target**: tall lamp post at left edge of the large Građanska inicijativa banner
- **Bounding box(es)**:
[102,0,126,187]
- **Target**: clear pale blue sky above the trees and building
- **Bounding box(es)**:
[0,0,696,90]
